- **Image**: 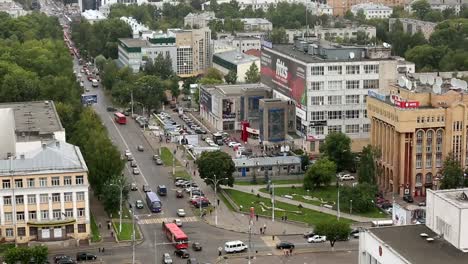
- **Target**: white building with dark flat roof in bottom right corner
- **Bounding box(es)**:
[358,189,468,264]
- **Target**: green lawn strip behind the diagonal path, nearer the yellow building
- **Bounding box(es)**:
[260,185,388,218]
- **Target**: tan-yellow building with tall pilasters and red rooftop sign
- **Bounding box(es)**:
[367,75,468,196]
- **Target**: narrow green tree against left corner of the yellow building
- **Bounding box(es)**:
[358,145,381,184]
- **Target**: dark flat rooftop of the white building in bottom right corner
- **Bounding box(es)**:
[368,225,468,264]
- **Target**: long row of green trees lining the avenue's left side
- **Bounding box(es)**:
[0,13,127,210]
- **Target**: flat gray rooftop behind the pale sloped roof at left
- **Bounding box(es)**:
[0,101,65,142]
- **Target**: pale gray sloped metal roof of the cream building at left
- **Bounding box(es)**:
[0,141,88,175]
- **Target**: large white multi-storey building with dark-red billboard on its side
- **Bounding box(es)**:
[261,38,412,153]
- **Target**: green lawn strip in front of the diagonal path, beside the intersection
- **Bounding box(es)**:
[225,189,353,225]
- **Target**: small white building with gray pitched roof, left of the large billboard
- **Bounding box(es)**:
[213,50,260,83]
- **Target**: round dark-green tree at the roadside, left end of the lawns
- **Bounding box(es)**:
[196,150,235,186]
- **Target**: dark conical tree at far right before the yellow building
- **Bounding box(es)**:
[440,153,463,189]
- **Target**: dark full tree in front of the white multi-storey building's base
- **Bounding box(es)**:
[320,132,353,171]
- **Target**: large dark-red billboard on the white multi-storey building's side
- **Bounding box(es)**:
[261,49,307,109]
